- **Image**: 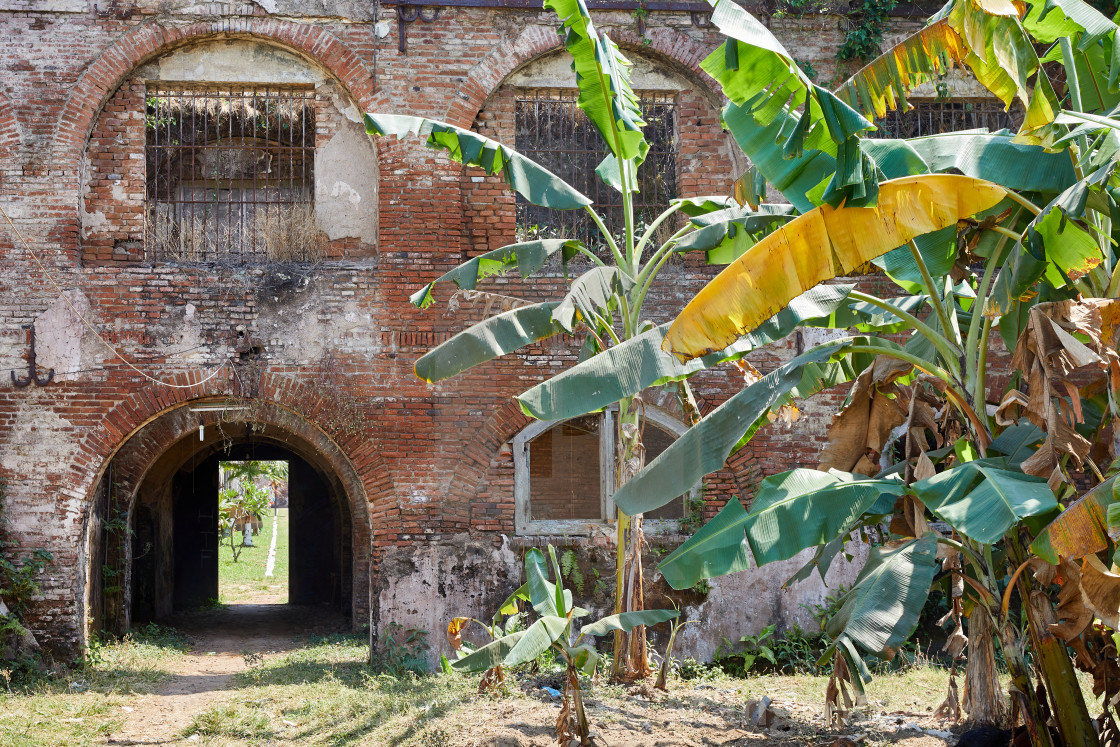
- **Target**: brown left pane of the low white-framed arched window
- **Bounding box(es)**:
[529,415,603,521]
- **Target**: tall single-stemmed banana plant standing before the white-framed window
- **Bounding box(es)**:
[365,0,860,680]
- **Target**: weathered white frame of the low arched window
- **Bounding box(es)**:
[510,405,700,536]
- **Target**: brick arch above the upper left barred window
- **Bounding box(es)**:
[52,18,376,169]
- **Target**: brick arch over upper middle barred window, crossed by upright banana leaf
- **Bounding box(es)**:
[445,26,718,128]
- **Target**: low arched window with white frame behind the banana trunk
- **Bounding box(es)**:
[513,408,700,535]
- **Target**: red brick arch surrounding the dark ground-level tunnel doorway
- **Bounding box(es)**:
[66,373,400,642]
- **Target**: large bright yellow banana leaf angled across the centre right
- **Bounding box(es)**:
[662,174,1007,361]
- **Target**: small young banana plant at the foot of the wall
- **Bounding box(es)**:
[448,544,680,746]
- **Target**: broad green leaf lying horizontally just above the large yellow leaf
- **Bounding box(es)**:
[859,132,1076,194]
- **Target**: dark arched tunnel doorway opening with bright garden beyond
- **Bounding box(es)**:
[86,408,365,634]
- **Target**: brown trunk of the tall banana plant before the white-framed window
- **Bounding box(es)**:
[610,398,652,682]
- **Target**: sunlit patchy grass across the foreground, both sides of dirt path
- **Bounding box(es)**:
[0,626,1092,747]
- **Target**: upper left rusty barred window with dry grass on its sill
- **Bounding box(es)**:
[144,85,326,261]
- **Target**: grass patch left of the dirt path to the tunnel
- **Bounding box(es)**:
[0,625,189,747]
